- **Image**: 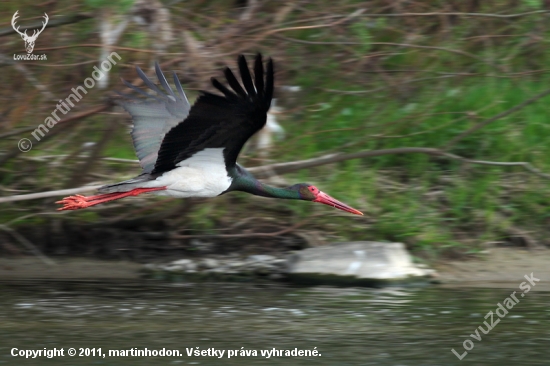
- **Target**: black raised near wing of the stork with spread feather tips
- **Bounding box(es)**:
[152,54,273,174]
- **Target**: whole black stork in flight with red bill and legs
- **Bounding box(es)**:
[56,54,362,215]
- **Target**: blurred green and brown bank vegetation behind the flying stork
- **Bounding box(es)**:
[0,0,550,259]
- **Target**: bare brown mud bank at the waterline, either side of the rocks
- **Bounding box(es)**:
[0,248,550,291]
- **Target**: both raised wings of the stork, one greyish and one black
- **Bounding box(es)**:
[119,54,273,174]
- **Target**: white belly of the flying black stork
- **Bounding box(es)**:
[142,148,231,198]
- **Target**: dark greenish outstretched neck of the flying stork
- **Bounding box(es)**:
[228,165,301,200]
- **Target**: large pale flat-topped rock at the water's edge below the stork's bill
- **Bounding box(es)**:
[288,241,433,285]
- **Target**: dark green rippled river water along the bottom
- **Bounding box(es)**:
[0,282,550,366]
